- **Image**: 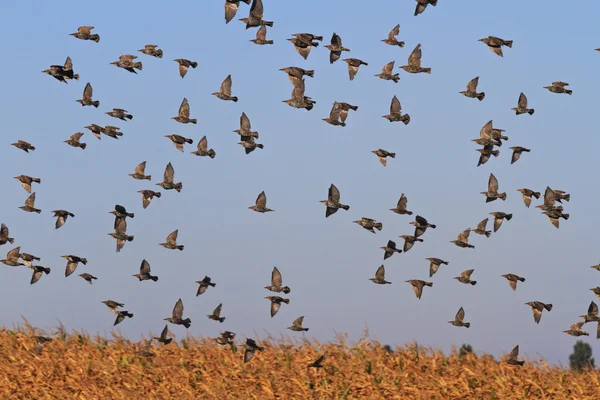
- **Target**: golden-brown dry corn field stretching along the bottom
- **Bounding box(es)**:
[0,327,600,400]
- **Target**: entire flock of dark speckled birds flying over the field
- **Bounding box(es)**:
[0,0,600,367]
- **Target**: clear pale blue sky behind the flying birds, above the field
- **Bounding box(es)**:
[0,0,600,362]
